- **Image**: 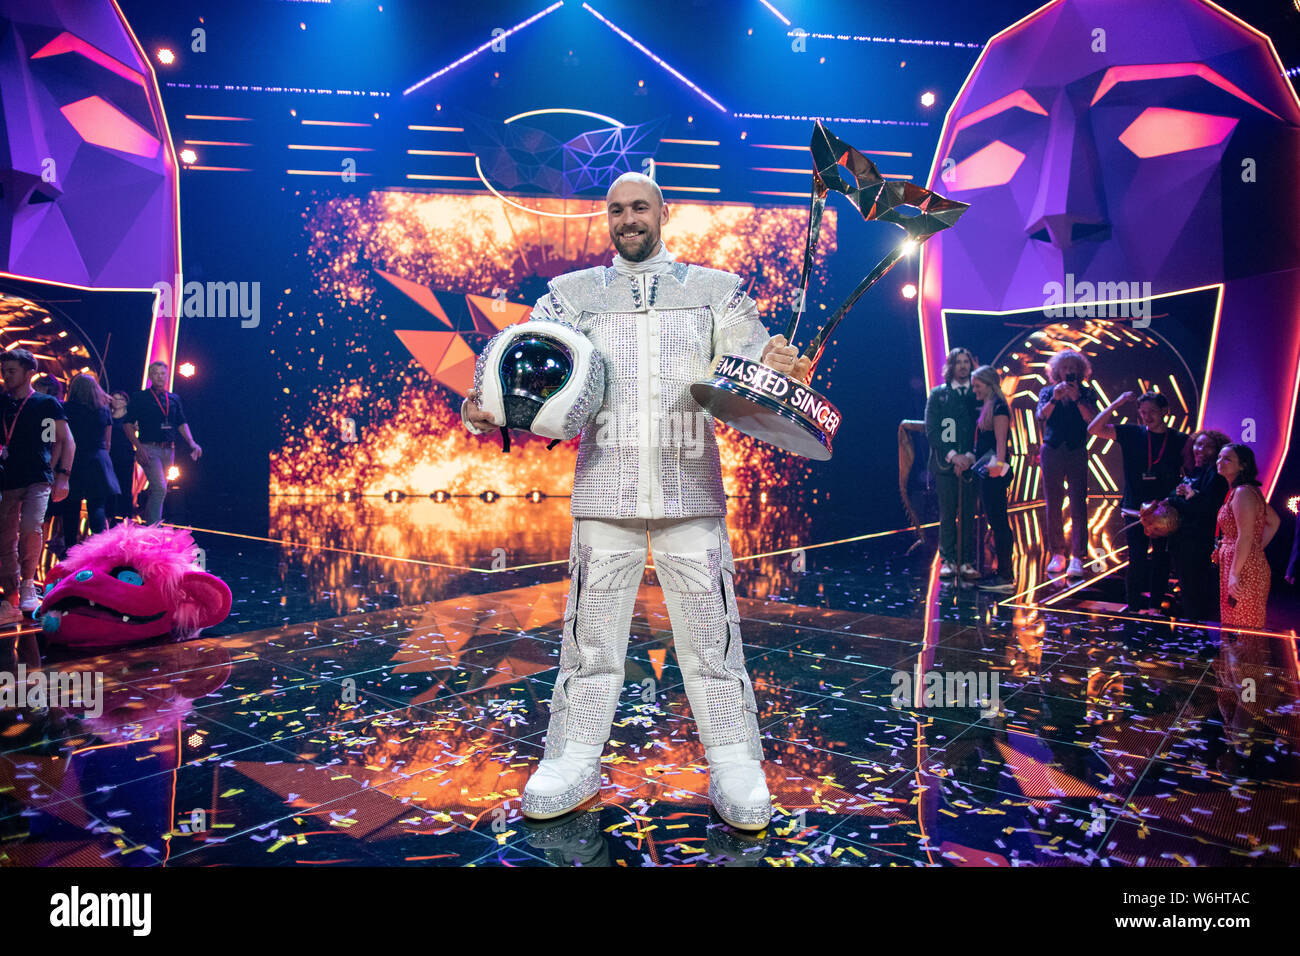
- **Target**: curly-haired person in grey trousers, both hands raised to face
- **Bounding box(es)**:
[1036,349,1097,578]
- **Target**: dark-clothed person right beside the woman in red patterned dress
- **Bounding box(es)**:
[1166,428,1231,620]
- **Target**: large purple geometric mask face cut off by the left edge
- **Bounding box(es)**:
[0,0,179,297]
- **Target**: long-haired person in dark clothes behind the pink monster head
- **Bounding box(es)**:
[51,372,121,557]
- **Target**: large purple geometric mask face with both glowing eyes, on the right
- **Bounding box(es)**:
[920,0,1300,489]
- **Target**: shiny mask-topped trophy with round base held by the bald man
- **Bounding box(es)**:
[690,120,969,462]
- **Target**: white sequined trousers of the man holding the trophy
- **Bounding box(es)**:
[546,516,763,760]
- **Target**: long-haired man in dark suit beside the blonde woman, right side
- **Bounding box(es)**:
[926,349,979,580]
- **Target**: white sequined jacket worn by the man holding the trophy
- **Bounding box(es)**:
[465,254,770,518]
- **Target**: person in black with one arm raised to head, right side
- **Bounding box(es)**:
[1088,392,1187,617]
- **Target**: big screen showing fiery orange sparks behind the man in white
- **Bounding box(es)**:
[270,191,836,496]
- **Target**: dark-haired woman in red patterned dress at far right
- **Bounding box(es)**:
[1214,445,1282,628]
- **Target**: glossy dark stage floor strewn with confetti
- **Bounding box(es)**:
[0,501,1300,866]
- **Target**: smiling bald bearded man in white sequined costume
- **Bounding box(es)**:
[462,173,809,830]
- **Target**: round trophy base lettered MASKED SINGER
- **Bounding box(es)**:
[690,355,842,462]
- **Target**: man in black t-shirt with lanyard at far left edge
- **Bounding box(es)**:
[0,349,75,624]
